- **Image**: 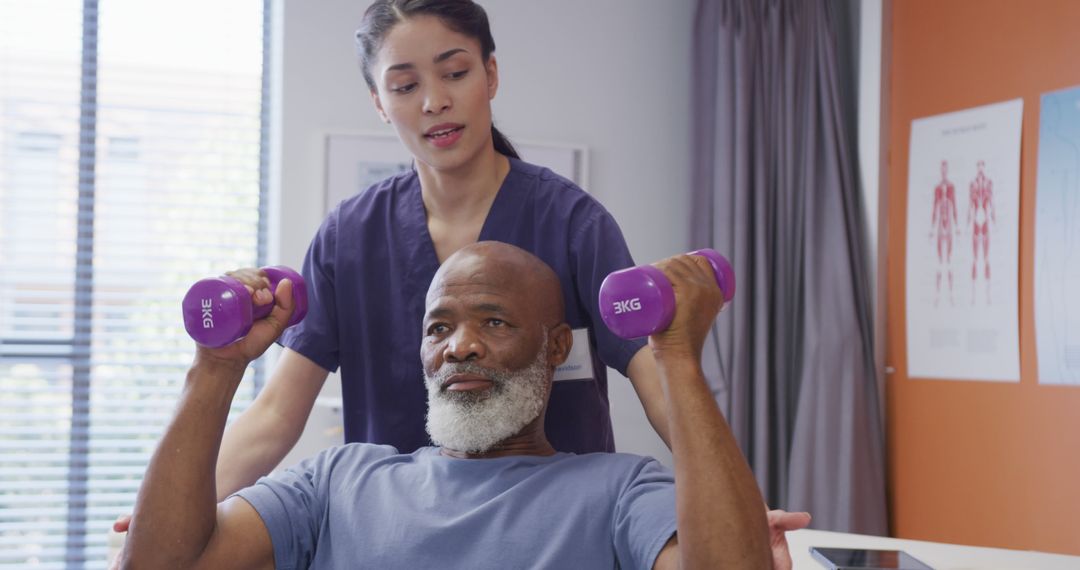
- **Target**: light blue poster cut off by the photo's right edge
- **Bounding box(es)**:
[1035,87,1080,385]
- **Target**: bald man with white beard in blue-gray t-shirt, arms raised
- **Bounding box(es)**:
[123,242,806,569]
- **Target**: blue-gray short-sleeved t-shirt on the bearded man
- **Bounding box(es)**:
[237,444,675,569]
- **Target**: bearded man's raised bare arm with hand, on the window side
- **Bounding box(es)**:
[121,281,293,569]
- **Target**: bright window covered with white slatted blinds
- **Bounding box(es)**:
[0,0,270,568]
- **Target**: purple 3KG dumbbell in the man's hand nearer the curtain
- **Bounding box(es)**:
[599,249,735,339]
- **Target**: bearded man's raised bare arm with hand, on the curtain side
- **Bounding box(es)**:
[649,255,772,570]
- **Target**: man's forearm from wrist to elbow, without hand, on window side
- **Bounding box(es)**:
[125,358,243,568]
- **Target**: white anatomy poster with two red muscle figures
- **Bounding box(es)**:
[906,99,1024,382]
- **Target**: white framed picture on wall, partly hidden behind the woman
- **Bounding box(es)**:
[323,132,589,212]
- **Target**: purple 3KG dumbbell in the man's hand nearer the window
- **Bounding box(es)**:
[183,266,308,349]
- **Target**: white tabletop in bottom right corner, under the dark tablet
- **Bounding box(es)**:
[787,529,1080,570]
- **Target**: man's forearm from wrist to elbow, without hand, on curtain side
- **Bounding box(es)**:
[658,355,771,569]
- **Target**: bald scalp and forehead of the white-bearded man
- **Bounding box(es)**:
[427,242,564,327]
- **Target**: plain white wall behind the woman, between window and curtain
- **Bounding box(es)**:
[271,0,694,462]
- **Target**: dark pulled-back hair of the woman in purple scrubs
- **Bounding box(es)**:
[356,0,521,159]
